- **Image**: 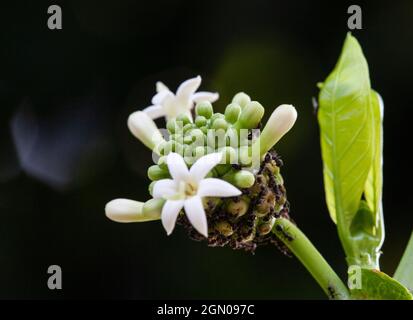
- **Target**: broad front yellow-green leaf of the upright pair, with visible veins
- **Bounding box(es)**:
[318,35,373,225]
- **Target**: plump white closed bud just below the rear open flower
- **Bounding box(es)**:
[128,111,165,150]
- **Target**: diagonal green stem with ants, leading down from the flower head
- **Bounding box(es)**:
[272,218,350,300]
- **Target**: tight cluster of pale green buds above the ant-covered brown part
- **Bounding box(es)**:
[148,92,264,190]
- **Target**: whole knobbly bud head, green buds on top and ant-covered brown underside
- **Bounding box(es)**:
[148,93,289,252]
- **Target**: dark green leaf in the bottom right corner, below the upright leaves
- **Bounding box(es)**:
[351,269,413,300]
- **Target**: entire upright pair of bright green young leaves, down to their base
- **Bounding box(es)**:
[318,34,384,267]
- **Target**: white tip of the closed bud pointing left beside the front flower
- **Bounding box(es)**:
[105,199,147,222]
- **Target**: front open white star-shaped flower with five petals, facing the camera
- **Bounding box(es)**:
[153,153,241,237]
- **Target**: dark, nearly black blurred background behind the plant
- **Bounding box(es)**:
[0,0,413,299]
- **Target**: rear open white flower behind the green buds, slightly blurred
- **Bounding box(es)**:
[143,76,219,120]
